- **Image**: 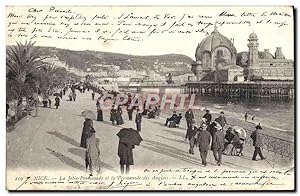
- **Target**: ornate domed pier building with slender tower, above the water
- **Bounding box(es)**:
[191,28,294,82]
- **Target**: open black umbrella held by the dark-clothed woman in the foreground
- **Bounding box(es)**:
[117,128,143,145]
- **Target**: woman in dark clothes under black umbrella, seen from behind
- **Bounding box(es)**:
[117,128,143,174]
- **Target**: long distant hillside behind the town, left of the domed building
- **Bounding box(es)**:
[41,47,193,73]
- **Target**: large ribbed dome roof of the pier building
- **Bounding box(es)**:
[195,28,236,60]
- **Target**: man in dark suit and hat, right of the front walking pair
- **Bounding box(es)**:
[211,122,225,166]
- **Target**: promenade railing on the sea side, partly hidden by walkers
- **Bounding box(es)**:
[158,111,295,160]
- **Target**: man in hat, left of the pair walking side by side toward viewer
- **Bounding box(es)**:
[197,123,211,166]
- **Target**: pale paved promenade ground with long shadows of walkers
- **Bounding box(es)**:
[7,91,291,173]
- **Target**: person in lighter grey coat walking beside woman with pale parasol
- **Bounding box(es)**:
[85,130,100,176]
